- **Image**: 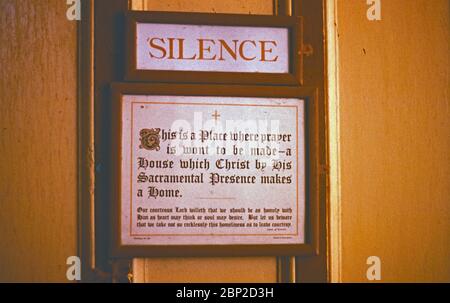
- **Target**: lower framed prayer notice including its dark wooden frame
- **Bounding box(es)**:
[111,83,318,257]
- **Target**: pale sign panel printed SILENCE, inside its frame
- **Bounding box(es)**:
[136,23,289,73]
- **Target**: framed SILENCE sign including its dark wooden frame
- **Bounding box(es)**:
[126,12,303,85]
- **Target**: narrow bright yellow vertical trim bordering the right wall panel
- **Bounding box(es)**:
[325,0,342,282]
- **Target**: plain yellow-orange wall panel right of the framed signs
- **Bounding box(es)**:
[337,0,450,282]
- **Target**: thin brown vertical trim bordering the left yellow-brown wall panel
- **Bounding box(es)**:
[78,1,96,280]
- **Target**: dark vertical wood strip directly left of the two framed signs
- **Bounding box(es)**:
[93,0,130,280]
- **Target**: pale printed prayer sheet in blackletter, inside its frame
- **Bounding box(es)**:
[120,95,305,245]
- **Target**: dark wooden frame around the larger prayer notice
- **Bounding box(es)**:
[110,83,319,257]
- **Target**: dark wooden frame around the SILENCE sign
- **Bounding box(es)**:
[125,11,303,85]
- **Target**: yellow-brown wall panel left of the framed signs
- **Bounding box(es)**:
[0,0,77,281]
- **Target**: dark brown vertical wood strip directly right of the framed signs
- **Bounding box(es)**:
[292,0,329,282]
